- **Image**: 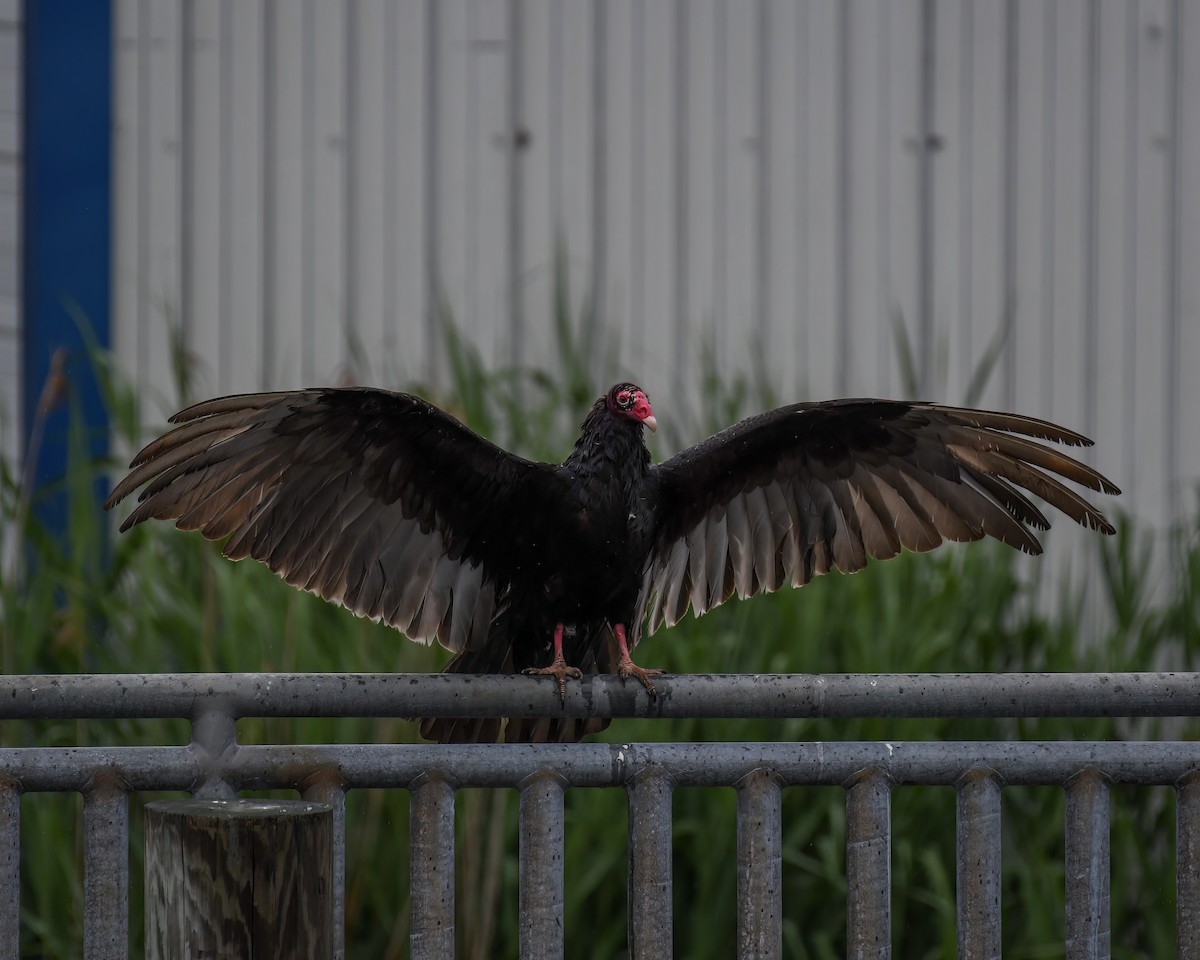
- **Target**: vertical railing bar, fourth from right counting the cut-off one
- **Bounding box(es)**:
[846,769,892,960]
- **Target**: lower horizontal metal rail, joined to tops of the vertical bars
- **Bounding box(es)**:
[0,740,1200,791]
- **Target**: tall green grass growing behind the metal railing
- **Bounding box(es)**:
[0,331,1200,958]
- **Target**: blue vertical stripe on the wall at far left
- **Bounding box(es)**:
[22,0,113,535]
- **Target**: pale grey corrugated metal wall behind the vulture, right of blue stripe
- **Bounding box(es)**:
[114,0,1200,522]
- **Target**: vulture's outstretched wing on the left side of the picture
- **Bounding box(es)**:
[106,389,553,650]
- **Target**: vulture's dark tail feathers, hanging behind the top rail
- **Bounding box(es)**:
[420,614,618,743]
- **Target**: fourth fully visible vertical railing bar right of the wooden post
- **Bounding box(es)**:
[737,769,784,960]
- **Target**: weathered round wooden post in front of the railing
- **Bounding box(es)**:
[145,800,334,960]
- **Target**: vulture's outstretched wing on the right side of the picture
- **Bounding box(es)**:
[638,400,1120,632]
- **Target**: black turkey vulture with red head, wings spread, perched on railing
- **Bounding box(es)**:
[106,383,1118,742]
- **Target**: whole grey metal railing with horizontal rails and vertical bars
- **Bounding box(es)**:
[0,673,1200,960]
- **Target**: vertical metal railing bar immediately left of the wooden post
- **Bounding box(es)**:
[83,778,130,960]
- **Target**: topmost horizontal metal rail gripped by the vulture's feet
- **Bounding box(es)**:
[0,673,1200,720]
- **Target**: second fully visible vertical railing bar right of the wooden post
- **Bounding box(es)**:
[520,772,565,960]
